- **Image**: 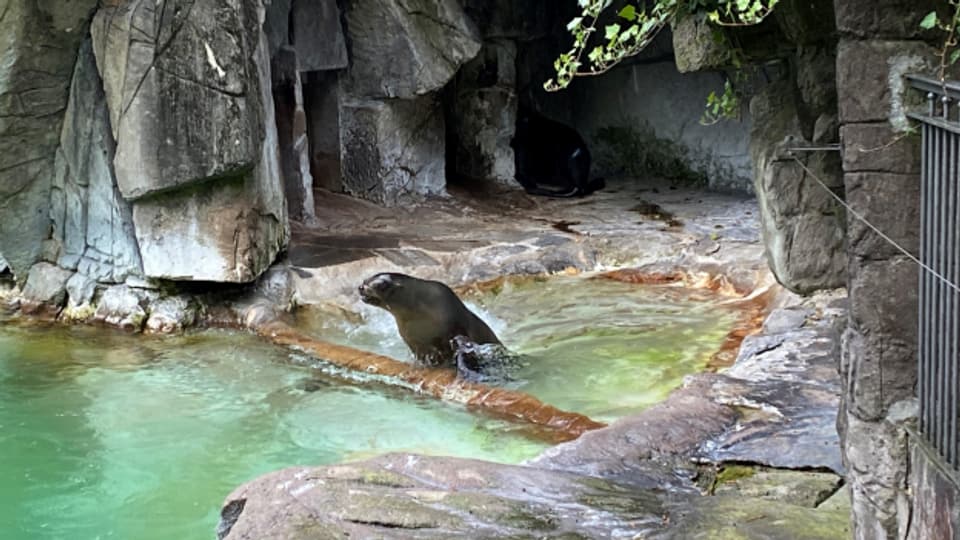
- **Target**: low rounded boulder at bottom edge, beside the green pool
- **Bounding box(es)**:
[217,454,673,540]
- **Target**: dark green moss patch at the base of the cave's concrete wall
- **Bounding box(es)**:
[594,126,707,186]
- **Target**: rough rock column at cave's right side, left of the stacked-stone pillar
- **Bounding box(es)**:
[750,0,846,293]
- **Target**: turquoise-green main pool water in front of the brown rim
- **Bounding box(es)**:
[0,323,543,540]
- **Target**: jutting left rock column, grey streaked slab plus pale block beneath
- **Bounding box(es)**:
[92,0,288,282]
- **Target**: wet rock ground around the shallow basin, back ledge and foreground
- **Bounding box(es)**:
[219,182,849,538]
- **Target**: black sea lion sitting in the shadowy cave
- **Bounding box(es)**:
[510,105,606,197]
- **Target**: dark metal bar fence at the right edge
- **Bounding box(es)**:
[909,76,960,468]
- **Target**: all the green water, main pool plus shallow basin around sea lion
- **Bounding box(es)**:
[0,277,736,540]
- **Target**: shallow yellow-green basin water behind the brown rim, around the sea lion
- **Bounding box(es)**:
[300,276,736,422]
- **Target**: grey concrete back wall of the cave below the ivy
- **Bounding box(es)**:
[571,58,753,193]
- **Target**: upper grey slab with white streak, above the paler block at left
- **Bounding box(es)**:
[91,0,264,200]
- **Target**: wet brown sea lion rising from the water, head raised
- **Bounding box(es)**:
[359,273,501,367]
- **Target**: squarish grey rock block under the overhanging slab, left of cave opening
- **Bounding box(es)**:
[340,95,446,205]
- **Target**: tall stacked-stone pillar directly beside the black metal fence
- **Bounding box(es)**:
[835,0,946,539]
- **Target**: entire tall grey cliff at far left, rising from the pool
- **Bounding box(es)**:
[0,0,288,327]
